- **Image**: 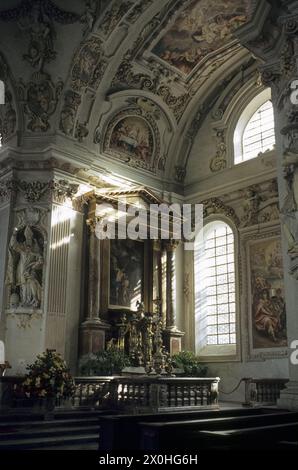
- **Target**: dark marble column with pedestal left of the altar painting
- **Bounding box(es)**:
[81,219,110,355]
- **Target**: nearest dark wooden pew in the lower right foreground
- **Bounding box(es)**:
[139,410,298,451]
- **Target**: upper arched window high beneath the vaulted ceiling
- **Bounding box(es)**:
[234,90,275,164]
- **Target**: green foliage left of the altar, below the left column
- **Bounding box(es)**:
[79,346,130,376]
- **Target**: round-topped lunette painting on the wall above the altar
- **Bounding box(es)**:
[110,116,153,163]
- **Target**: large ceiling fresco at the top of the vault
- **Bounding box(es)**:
[152,0,249,75]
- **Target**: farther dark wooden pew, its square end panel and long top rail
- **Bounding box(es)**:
[99,408,284,450]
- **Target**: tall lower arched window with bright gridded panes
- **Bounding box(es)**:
[195,220,236,355]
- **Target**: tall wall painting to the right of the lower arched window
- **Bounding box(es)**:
[250,238,287,349]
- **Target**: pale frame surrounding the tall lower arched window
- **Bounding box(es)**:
[194,214,241,362]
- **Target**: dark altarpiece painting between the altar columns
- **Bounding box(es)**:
[110,240,144,310]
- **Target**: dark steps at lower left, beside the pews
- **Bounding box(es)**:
[0,411,113,451]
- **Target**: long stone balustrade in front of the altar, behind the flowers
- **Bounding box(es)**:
[0,376,220,412]
